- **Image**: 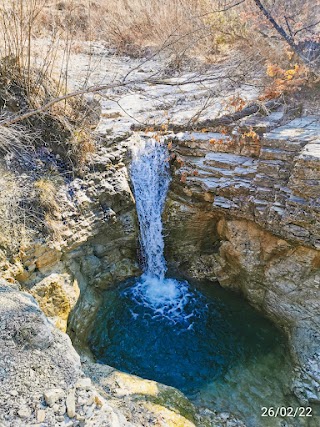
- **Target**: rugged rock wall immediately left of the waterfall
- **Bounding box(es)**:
[1,141,140,350]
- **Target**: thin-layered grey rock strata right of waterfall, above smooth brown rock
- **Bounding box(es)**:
[166,116,320,247]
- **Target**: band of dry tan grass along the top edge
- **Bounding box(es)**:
[0,0,319,79]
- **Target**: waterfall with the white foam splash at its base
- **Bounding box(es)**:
[131,138,198,321]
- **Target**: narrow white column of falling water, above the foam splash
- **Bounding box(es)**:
[131,138,170,279]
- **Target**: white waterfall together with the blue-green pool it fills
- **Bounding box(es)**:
[89,139,307,427]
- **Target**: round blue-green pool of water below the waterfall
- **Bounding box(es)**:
[89,279,308,426]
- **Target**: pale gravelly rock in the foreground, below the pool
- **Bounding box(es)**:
[0,279,248,427]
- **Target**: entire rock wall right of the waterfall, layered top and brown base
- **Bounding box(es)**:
[164,114,320,401]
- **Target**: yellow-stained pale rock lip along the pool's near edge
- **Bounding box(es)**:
[84,362,245,427]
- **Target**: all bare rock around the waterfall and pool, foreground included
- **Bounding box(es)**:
[0,41,320,427]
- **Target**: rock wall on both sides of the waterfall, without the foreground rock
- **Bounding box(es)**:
[0,59,320,408]
